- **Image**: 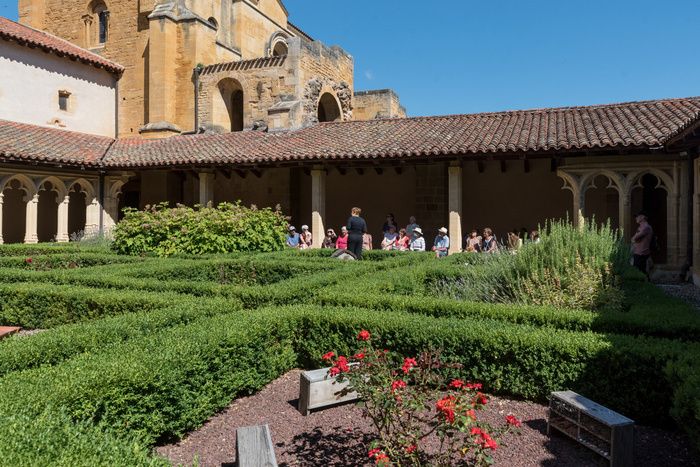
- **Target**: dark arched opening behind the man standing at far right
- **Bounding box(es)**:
[629,174,668,264]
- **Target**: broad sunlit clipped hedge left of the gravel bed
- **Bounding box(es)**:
[0,316,296,446]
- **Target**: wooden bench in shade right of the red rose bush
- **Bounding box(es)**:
[547,391,634,467]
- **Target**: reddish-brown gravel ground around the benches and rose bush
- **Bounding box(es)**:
[158,371,700,467]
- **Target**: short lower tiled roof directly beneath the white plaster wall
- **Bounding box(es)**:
[0,120,114,166]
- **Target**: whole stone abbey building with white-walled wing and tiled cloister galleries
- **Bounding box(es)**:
[0,0,700,281]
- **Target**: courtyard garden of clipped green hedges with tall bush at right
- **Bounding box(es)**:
[0,216,700,466]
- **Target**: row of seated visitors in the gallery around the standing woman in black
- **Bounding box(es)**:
[287,214,540,258]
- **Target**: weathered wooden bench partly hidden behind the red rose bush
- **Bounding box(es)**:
[299,368,357,416]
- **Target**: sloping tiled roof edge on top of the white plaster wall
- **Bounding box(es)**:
[0,16,124,73]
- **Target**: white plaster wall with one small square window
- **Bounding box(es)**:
[0,40,116,137]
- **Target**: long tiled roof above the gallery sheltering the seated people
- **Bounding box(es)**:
[104,97,700,167]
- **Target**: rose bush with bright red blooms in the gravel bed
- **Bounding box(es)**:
[322,330,520,466]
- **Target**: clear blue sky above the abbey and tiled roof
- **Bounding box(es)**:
[0,0,700,115]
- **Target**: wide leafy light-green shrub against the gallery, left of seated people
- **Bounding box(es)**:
[112,203,287,256]
